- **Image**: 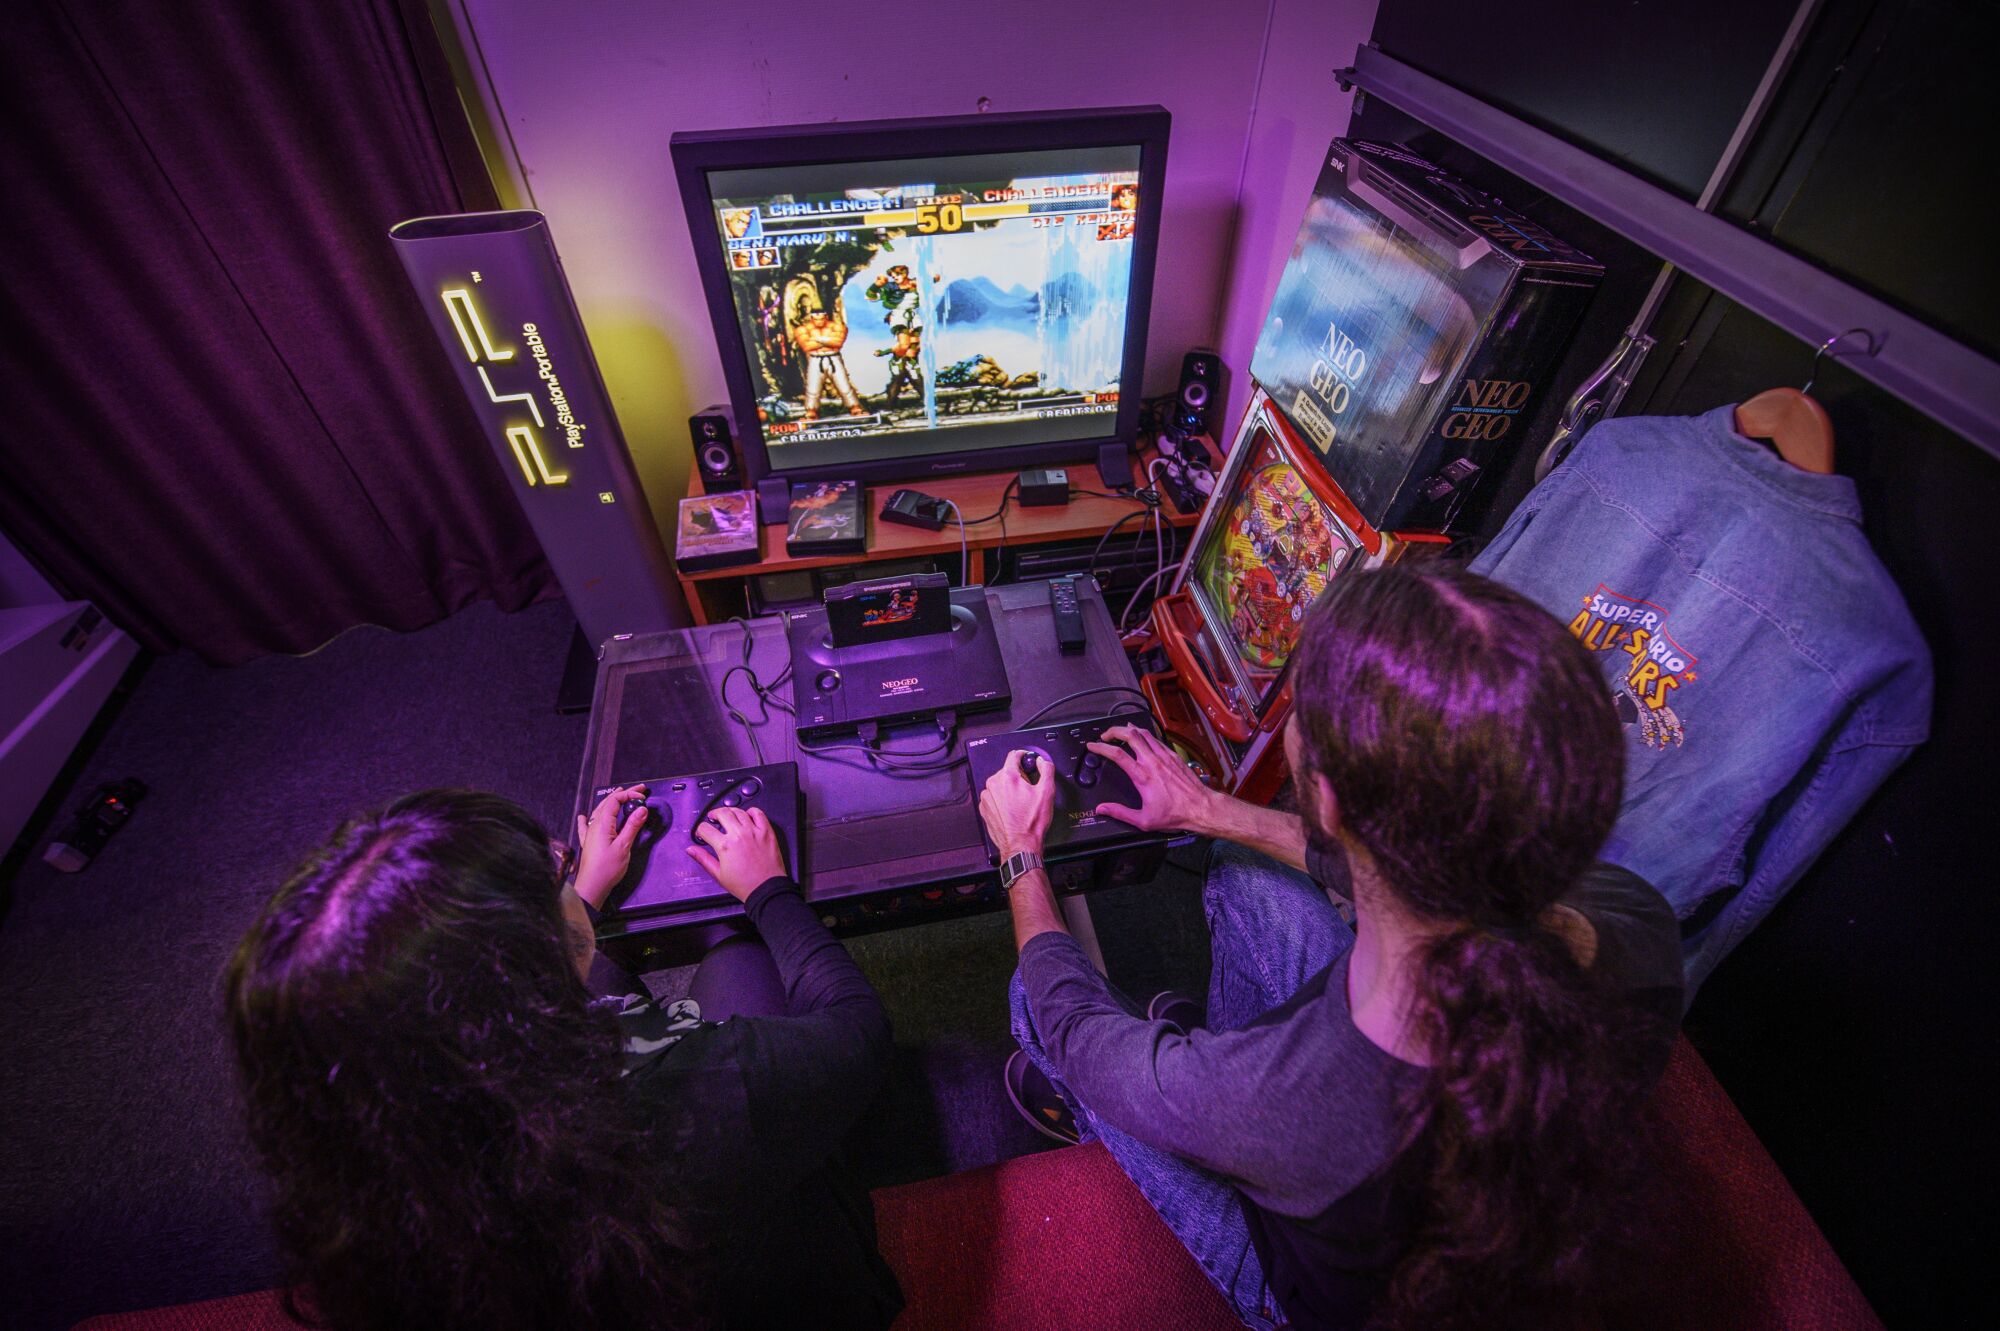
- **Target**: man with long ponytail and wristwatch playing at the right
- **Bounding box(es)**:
[980,566,1682,1329]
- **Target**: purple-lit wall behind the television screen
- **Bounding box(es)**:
[450,0,1376,516]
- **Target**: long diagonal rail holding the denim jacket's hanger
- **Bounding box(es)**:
[1336,46,2000,458]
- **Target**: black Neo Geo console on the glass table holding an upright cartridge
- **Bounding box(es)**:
[784,584,1014,743]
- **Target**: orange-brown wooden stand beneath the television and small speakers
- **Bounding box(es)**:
[668,454,1200,624]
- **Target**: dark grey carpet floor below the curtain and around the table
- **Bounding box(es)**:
[0,604,1208,1331]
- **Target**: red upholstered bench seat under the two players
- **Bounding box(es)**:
[78,1039,1882,1331]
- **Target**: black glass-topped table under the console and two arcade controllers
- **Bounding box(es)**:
[576,578,1164,965]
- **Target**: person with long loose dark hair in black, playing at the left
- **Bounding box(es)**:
[224,787,902,1331]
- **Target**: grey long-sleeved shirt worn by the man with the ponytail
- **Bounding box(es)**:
[1020,865,1682,1327]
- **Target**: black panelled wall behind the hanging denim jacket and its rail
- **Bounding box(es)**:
[1352,0,2000,1327]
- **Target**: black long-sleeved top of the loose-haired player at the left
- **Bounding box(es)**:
[592,877,902,1331]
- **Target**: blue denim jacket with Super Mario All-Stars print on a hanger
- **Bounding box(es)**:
[1472,406,1930,997]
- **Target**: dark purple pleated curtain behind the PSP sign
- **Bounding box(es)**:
[0,0,554,664]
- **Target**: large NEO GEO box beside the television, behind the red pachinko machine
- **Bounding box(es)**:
[1250,138,1604,532]
